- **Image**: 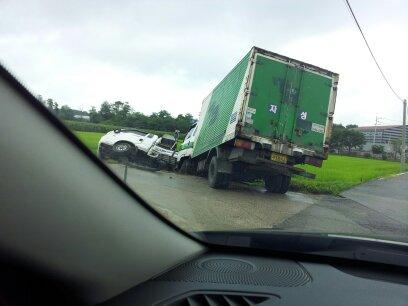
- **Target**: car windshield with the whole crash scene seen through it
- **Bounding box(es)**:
[0,0,408,251]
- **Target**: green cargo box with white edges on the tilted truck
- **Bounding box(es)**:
[192,47,338,159]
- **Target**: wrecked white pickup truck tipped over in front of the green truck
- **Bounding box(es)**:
[98,129,178,168]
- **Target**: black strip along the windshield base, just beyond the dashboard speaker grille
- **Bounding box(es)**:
[195,230,408,267]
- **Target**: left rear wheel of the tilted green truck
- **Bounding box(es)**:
[206,147,233,188]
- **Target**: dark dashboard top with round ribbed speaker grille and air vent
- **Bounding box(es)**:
[99,253,408,306]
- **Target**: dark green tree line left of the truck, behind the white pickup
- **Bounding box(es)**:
[37,96,195,133]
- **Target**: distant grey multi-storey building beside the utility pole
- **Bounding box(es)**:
[355,125,408,152]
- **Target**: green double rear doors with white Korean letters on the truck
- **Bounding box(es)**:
[244,54,332,153]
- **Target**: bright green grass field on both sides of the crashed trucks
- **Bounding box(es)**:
[74,132,400,195]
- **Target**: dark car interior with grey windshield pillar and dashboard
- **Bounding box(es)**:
[0,63,408,306]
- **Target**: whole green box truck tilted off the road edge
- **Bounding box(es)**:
[177,47,339,193]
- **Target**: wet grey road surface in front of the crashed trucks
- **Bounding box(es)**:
[110,164,408,240]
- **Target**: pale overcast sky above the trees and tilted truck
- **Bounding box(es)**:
[0,0,408,125]
